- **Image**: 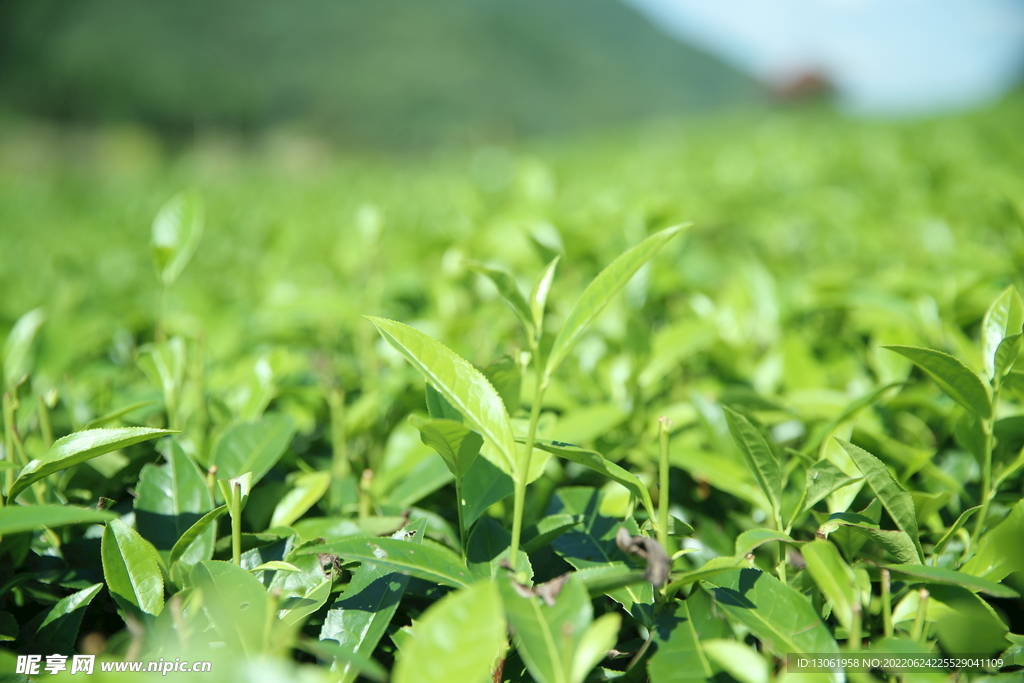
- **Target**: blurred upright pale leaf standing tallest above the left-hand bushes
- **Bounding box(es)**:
[151,193,204,287]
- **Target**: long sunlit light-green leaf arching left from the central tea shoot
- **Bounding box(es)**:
[367,316,516,475]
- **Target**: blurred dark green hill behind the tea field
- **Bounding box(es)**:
[0,0,762,145]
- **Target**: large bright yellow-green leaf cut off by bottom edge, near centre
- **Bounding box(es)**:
[392,581,506,683]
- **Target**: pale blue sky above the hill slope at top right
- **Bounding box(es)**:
[627,0,1024,116]
